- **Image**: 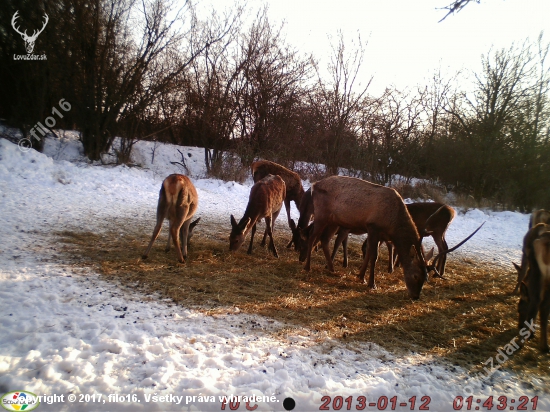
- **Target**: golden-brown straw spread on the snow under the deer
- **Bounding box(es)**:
[59,219,550,392]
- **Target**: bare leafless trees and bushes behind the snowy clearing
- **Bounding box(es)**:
[0,0,550,211]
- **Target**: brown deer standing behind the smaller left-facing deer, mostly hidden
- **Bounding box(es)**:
[250,160,304,248]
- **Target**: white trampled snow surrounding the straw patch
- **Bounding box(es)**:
[0,136,550,411]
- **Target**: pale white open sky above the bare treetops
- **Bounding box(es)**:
[200,0,550,93]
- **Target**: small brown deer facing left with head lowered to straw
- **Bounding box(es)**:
[229,174,286,258]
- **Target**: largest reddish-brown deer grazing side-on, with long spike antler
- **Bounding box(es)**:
[304,176,483,300]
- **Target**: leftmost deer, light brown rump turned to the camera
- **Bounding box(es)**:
[142,174,200,263]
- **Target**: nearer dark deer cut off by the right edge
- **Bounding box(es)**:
[515,223,550,352]
